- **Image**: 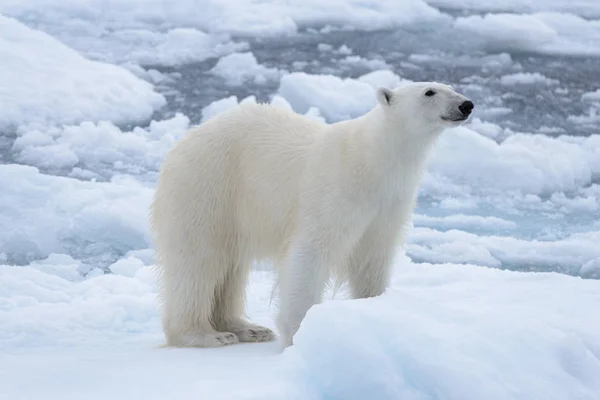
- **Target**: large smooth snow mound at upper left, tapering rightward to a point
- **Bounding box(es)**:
[0,15,166,127]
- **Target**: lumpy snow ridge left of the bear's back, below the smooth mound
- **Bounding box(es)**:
[12,113,190,179]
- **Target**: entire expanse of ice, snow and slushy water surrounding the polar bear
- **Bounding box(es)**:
[0,0,600,400]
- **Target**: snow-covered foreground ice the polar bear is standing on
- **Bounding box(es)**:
[0,257,600,400]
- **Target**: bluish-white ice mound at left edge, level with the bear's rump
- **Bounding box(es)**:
[0,164,153,264]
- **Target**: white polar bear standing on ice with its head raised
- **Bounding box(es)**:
[151,82,473,348]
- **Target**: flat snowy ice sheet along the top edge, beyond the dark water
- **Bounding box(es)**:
[0,0,441,64]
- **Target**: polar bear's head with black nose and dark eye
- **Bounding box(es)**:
[377,82,474,133]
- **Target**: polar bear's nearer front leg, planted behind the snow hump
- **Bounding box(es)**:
[277,241,329,348]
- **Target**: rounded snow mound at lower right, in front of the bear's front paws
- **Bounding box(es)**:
[284,264,600,400]
